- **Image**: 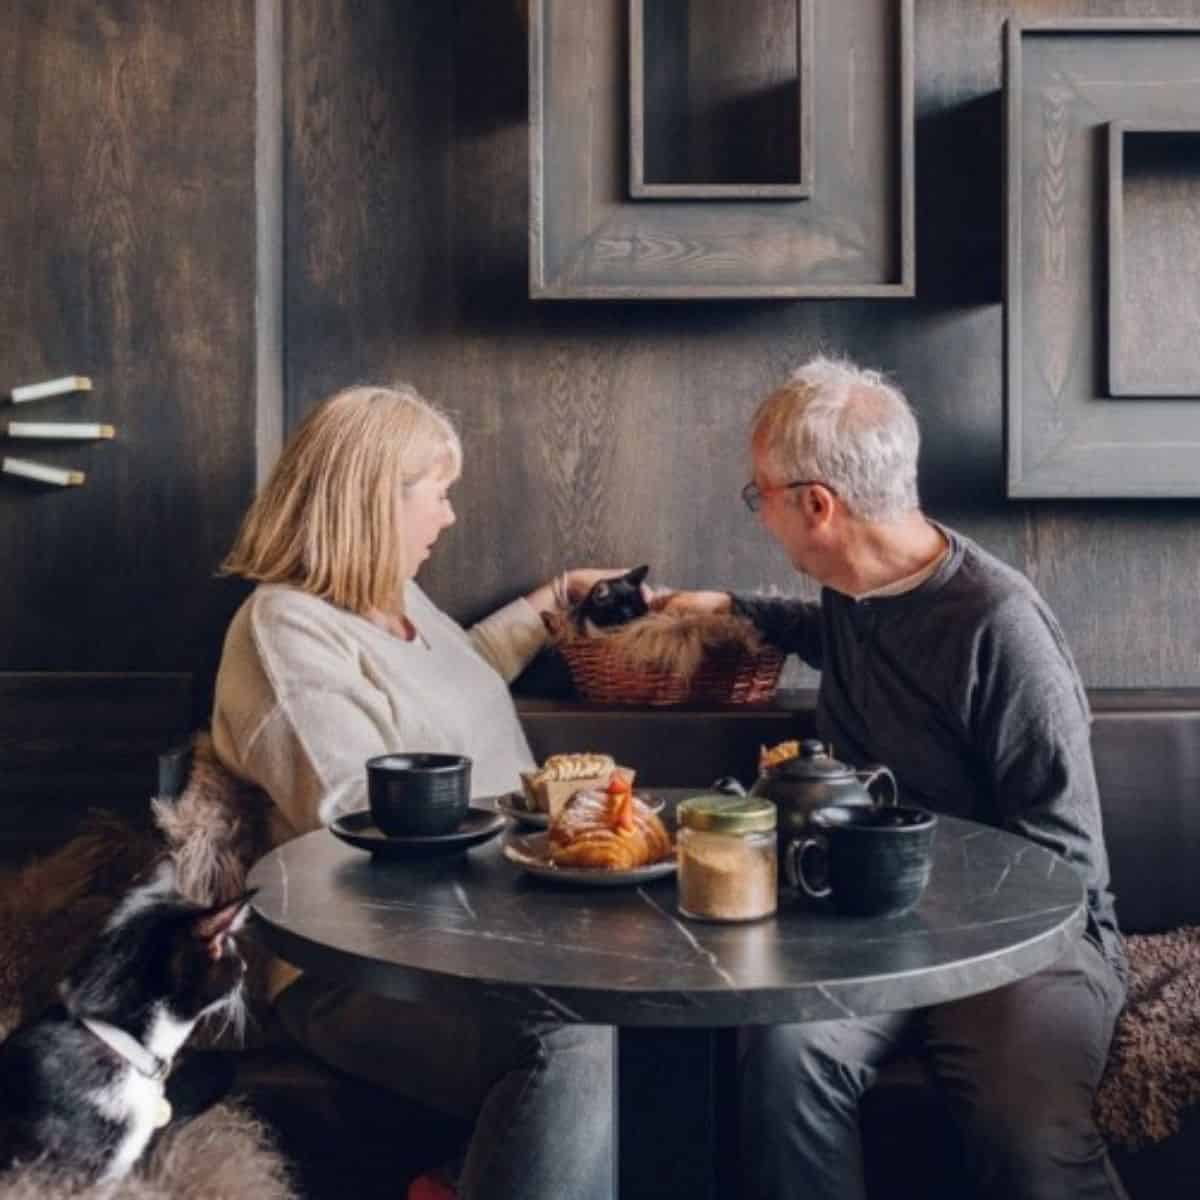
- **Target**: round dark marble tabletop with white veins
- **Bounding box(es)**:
[250,790,1085,1027]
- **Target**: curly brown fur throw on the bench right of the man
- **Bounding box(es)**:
[1096,925,1200,1148]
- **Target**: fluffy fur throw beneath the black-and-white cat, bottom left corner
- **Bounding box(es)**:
[0,1104,296,1200]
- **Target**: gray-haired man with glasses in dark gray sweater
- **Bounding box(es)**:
[667,359,1124,1200]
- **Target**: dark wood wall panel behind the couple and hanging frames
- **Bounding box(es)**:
[286,0,1200,686]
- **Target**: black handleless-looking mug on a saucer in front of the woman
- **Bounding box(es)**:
[367,754,470,838]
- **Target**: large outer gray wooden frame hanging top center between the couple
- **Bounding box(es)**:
[529,0,916,300]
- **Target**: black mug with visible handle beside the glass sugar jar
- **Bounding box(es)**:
[784,804,937,917]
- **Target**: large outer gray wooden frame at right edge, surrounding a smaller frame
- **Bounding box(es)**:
[1004,19,1200,499]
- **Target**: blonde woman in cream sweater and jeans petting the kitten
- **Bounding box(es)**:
[212,386,612,1200]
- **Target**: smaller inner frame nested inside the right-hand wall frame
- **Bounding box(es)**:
[1108,120,1200,398]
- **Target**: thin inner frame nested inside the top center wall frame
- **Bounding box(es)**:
[629,0,814,200]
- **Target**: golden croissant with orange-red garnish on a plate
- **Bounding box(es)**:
[550,790,674,871]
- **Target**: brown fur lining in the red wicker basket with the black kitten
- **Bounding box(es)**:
[542,612,763,679]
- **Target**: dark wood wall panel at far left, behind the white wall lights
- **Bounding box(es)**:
[0,0,254,854]
